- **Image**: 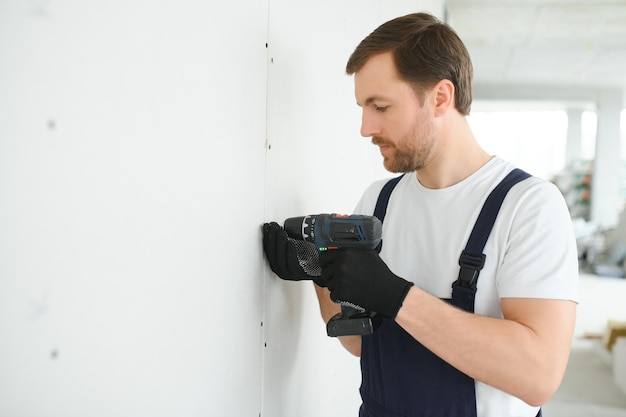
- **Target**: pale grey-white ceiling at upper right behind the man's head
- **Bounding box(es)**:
[446,0,626,107]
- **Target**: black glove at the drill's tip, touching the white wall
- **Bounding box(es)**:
[263,222,326,287]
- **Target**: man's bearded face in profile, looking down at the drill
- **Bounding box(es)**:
[354,53,436,172]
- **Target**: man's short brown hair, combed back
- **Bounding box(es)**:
[346,13,473,115]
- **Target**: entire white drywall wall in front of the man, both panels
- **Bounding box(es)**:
[0,0,441,417]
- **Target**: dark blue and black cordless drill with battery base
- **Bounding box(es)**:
[284,214,382,337]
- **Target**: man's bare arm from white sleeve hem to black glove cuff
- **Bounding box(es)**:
[396,288,575,405]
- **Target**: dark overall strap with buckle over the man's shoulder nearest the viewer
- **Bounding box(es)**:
[452,169,530,312]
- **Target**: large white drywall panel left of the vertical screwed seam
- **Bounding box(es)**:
[0,0,267,417]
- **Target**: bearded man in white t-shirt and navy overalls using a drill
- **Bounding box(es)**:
[264,13,578,417]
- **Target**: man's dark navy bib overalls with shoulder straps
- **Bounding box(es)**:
[359,170,541,417]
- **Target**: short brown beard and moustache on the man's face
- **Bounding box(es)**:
[372,115,436,173]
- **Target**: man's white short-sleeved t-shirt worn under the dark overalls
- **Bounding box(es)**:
[355,157,578,417]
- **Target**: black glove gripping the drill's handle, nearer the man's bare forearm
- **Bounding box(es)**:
[320,250,413,319]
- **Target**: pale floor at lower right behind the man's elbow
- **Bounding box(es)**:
[543,275,626,417]
